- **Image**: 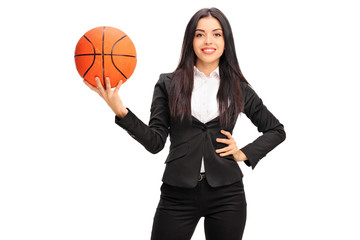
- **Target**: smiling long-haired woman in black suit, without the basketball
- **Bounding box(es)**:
[85,8,285,240]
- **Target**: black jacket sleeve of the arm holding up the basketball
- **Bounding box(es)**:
[115,74,170,153]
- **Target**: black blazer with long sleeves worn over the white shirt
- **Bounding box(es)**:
[115,74,285,188]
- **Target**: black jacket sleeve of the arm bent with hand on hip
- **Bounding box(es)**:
[241,85,286,169]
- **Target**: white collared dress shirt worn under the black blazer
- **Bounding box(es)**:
[191,66,220,172]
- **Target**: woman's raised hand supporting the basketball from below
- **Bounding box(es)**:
[84,77,128,118]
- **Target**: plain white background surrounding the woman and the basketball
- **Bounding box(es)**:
[0,0,360,240]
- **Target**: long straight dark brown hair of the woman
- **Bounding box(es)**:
[169,8,248,127]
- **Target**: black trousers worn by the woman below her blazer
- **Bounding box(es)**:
[151,178,246,240]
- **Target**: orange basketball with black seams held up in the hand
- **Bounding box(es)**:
[75,27,137,88]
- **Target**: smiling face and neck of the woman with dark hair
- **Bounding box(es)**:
[193,17,225,67]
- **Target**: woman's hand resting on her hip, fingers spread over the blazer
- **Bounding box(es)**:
[216,130,247,162]
